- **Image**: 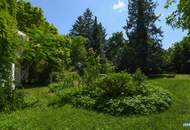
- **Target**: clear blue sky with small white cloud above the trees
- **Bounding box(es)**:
[28,0,185,48]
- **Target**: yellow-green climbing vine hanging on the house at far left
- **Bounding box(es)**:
[0,0,17,86]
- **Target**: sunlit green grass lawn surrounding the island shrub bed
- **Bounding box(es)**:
[0,75,190,130]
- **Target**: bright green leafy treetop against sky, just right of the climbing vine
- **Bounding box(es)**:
[16,0,58,34]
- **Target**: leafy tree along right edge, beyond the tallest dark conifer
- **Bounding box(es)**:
[166,0,190,73]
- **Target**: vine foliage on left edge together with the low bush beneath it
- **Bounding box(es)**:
[0,0,27,112]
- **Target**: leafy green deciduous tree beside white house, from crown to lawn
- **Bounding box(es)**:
[16,0,60,83]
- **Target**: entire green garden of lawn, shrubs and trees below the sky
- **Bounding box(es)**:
[0,0,190,130]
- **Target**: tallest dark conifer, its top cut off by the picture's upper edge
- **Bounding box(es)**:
[124,0,162,73]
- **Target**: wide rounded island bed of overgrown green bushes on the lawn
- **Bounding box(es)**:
[49,71,172,115]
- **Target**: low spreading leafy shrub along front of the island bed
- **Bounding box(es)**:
[96,88,171,115]
